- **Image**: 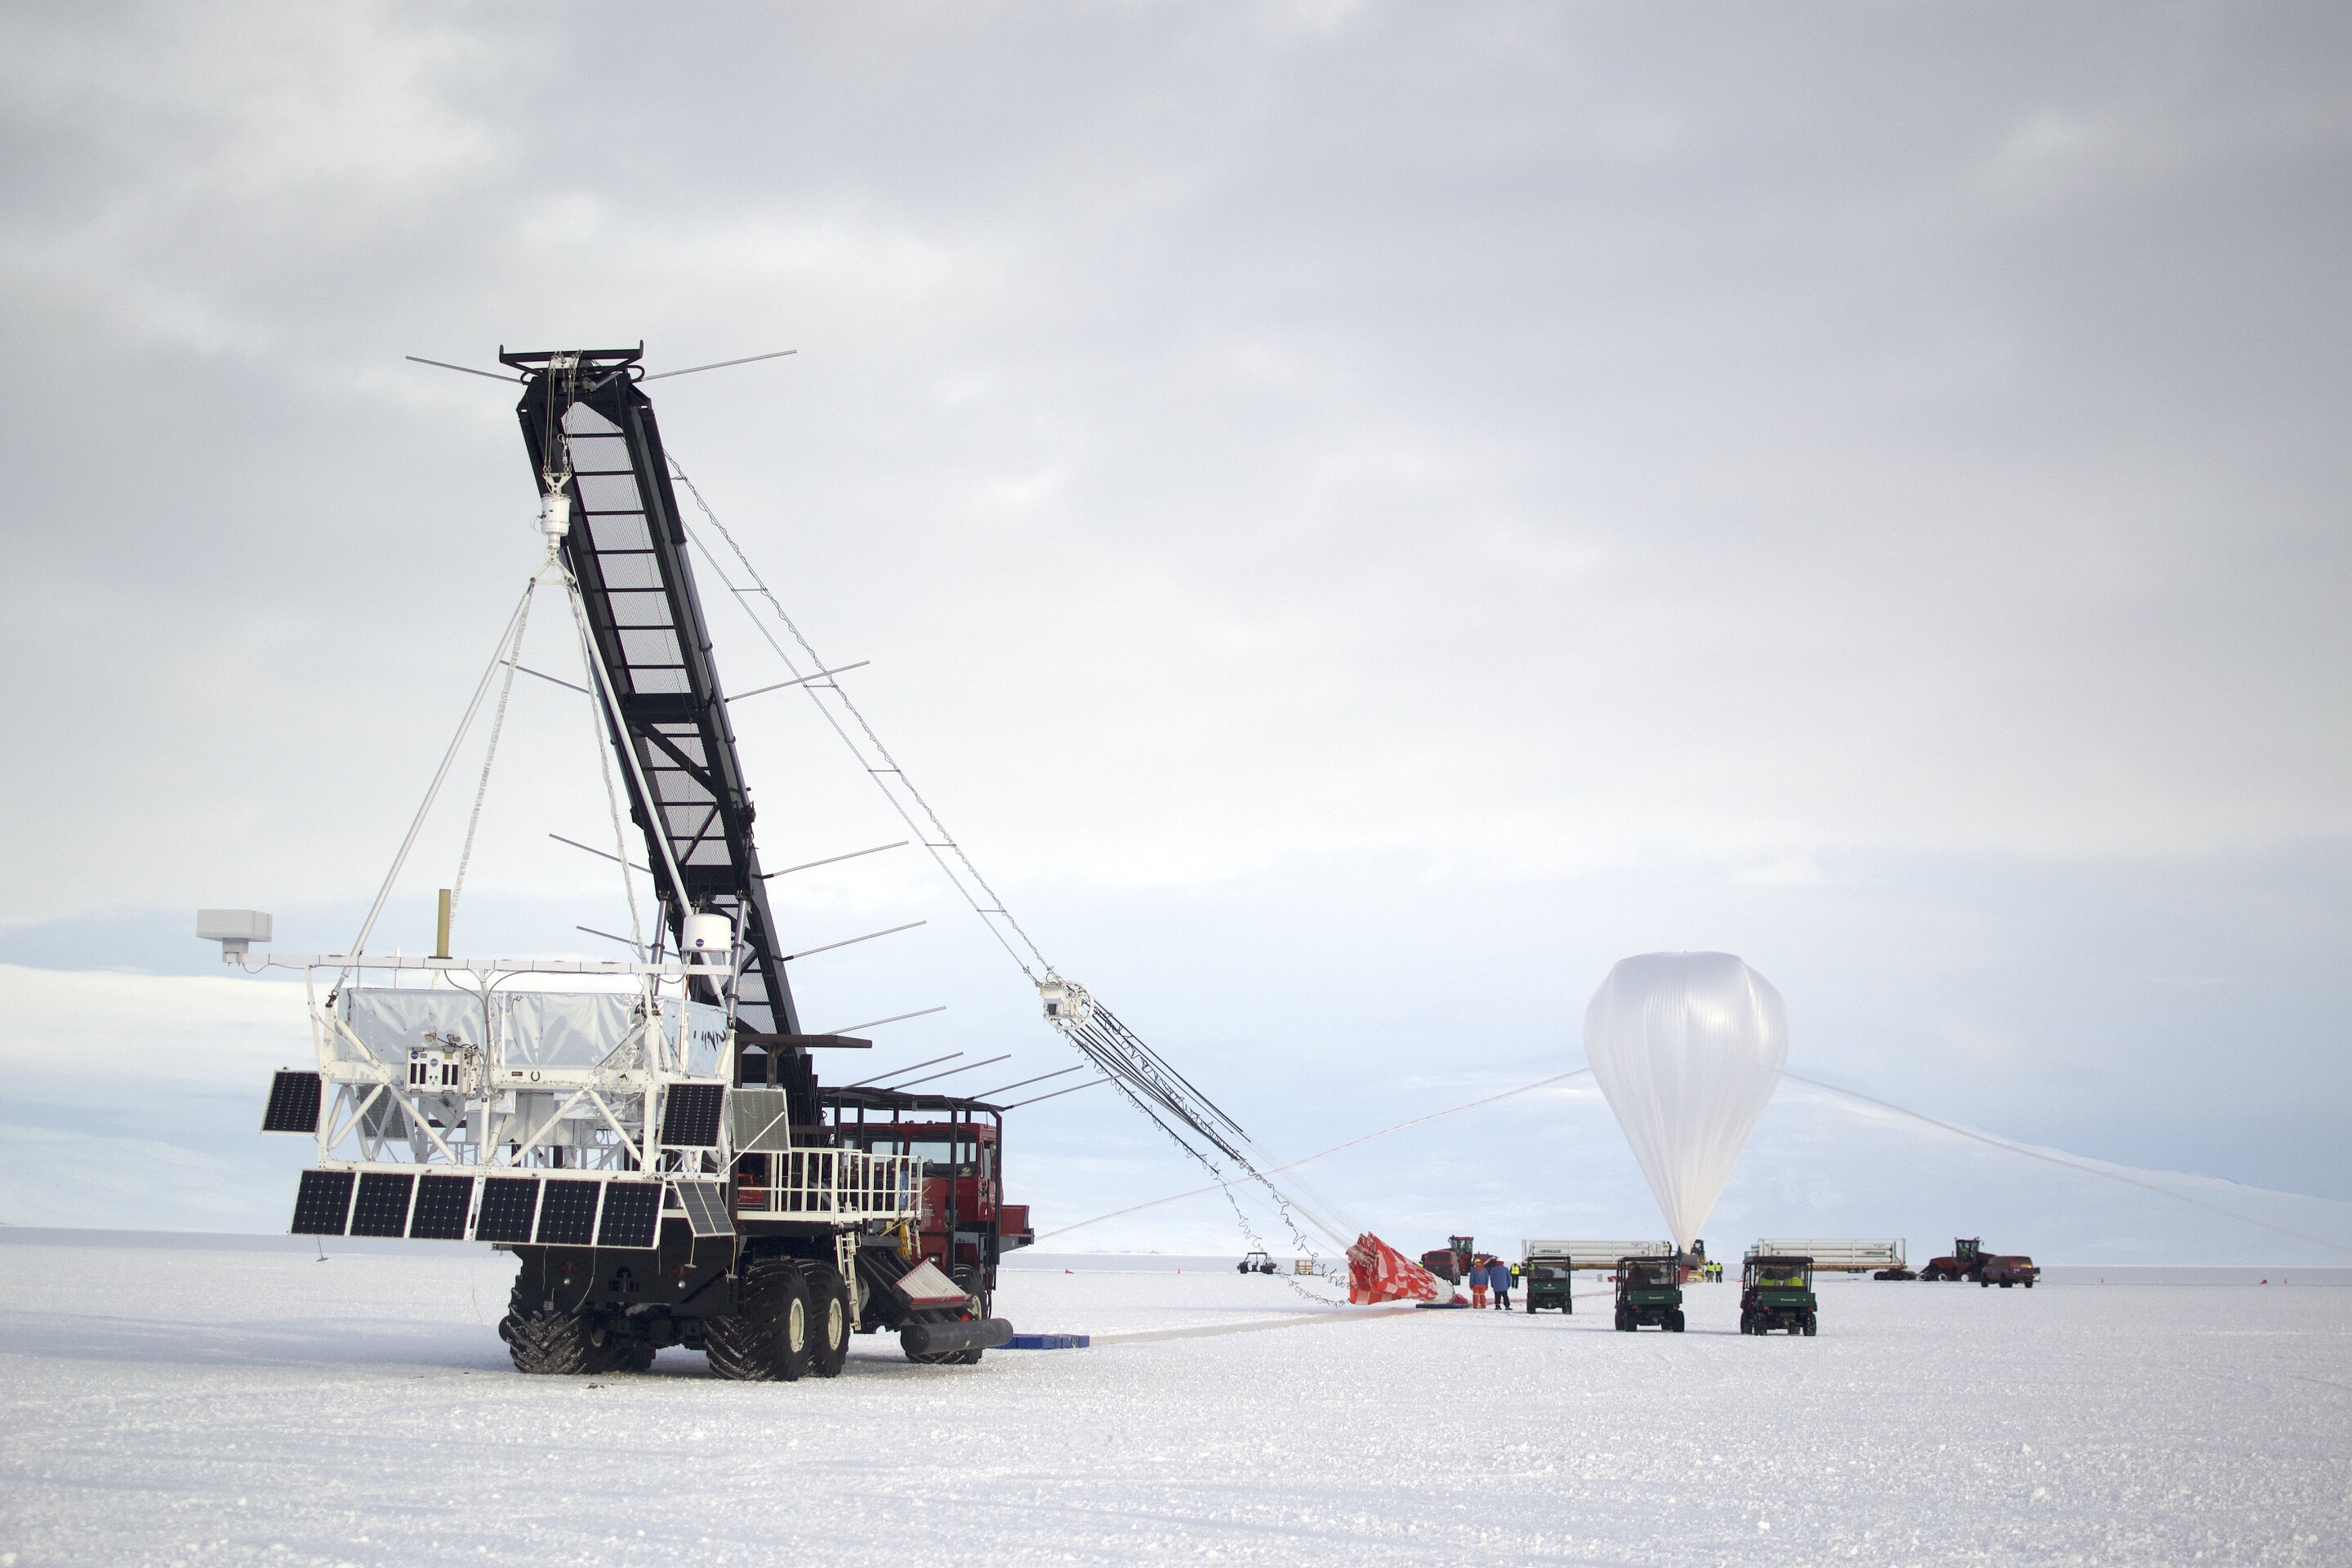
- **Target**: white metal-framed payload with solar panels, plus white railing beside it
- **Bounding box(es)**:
[264,955,922,1246]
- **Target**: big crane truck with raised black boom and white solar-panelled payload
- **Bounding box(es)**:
[226,350,1030,1380]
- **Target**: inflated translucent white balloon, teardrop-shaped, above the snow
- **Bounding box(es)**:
[1585,952,1788,1250]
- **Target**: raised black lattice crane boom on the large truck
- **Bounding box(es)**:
[499,345,818,1126]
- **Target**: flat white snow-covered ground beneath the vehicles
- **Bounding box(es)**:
[0,1229,2352,1568]
